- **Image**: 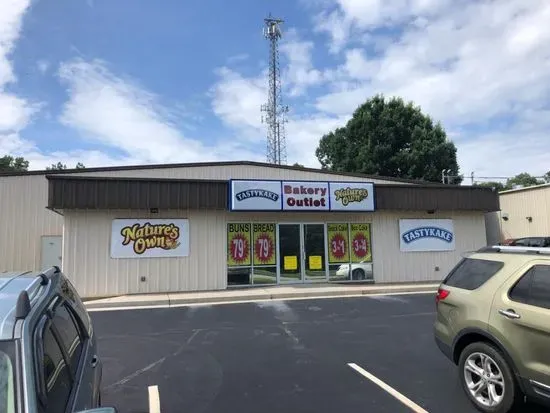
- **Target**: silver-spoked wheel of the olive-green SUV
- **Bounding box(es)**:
[458,342,521,413]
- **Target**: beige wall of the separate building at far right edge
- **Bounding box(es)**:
[500,185,550,239]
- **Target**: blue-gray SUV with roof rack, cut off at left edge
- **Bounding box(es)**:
[0,267,115,413]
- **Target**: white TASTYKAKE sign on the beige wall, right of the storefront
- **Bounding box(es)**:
[399,219,455,252]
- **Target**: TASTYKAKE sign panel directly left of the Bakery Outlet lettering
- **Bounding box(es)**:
[230,181,281,211]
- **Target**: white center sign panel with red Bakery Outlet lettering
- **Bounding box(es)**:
[283,181,329,211]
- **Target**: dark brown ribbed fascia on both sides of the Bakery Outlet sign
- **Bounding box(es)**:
[47,176,500,212]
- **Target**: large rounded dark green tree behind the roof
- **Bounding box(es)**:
[315,95,462,184]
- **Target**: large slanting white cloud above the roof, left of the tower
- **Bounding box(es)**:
[59,59,260,163]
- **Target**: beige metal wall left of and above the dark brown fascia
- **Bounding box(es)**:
[0,165,406,271]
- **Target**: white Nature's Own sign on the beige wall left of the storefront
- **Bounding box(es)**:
[111,219,189,258]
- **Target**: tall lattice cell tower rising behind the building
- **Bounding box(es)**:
[261,14,288,165]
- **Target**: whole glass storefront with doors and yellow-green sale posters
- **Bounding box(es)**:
[227,222,374,285]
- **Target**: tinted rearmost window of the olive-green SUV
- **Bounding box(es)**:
[443,258,504,290]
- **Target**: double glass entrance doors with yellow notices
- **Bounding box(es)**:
[278,224,327,284]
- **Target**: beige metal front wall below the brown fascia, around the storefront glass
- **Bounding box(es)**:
[63,210,486,297]
